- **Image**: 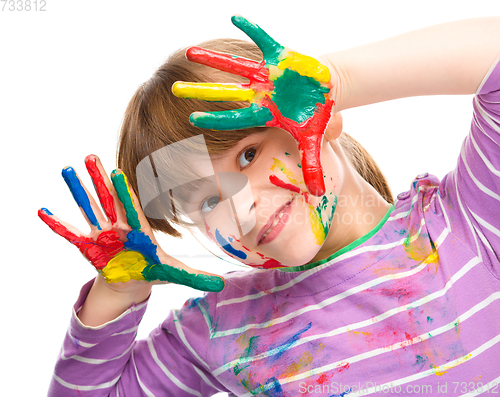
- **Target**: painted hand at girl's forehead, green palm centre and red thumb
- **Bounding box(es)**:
[172,16,334,196]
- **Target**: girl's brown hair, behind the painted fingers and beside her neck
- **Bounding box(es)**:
[118,39,393,237]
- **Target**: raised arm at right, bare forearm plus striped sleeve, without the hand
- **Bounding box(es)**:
[324,17,500,270]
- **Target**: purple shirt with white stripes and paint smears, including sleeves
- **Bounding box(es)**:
[49,57,500,397]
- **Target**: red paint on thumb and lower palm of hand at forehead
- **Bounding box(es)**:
[262,96,334,196]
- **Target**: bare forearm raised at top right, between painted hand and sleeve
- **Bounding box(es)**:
[322,17,500,111]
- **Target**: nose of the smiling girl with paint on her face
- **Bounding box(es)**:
[217,172,257,237]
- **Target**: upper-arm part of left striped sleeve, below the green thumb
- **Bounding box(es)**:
[120,294,228,397]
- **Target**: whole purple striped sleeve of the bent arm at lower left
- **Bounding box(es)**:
[48,281,224,397]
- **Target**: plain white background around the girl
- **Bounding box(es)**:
[0,0,500,396]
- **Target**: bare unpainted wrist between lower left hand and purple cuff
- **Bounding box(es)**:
[78,276,151,327]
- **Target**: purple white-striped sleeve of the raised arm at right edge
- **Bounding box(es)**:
[439,57,500,278]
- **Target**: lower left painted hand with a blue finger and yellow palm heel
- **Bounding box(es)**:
[38,155,224,292]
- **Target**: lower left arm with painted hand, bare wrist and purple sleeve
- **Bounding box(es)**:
[38,156,224,396]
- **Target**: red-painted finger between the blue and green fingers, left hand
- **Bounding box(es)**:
[85,155,120,224]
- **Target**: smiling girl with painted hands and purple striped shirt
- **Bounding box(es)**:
[39,14,500,396]
